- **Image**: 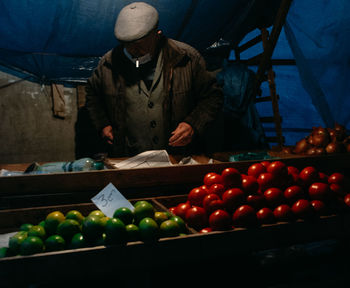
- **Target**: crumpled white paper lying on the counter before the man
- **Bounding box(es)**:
[110,150,172,169]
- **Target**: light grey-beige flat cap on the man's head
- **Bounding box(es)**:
[114,2,159,42]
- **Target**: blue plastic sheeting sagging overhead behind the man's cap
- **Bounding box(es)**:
[0,0,280,83]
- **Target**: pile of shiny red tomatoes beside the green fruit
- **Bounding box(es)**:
[170,161,350,232]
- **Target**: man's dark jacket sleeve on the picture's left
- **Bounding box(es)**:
[85,58,111,132]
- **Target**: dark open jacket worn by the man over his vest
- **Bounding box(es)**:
[86,37,223,157]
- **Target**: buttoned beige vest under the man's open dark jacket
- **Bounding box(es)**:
[125,52,168,154]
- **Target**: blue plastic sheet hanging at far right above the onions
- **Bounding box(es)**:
[285,0,350,128]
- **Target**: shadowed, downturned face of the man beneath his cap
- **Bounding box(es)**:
[124,30,158,58]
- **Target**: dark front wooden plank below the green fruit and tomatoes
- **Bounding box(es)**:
[0,216,349,287]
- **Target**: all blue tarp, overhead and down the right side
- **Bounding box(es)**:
[0,0,350,144]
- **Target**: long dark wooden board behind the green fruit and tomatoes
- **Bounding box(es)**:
[0,152,350,209]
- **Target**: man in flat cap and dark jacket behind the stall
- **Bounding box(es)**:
[86,2,223,157]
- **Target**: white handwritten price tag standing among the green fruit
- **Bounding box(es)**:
[91,183,134,217]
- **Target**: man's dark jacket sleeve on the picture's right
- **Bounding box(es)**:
[184,52,224,135]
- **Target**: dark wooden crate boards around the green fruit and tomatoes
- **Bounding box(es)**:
[0,155,350,287]
